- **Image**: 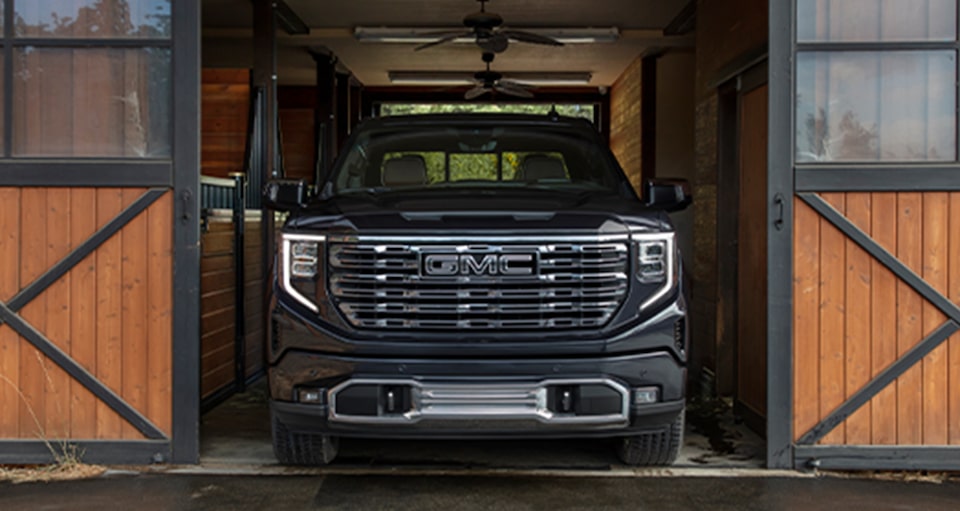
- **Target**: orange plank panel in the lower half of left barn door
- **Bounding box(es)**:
[0,188,173,439]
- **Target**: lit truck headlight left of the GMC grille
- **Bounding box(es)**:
[278,234,326,312]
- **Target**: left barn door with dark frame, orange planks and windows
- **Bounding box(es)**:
[0,0,199,463]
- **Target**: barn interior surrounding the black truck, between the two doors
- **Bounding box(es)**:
[200,0,767,468]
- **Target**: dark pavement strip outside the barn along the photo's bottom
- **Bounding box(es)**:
[0,474,960,511]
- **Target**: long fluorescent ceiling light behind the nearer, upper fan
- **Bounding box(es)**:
[353,27,620,44]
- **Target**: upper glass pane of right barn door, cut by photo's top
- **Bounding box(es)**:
[797,0,957,42]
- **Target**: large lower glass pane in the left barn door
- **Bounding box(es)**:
[13,47,171,158]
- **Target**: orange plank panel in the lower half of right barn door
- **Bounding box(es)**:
[793,193,960,445]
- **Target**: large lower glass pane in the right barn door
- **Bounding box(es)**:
[796,51,957,162]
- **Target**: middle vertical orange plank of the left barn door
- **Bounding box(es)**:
[70,188,98,439]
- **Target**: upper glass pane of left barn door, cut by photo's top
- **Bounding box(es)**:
[14,0,170,38]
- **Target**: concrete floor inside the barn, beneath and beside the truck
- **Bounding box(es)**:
[200,380,763,473]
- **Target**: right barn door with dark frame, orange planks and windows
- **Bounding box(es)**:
[768,0,960,470]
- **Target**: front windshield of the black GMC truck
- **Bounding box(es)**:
[330,127,624,194]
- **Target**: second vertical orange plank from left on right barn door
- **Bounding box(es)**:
[820,193,847,445]
